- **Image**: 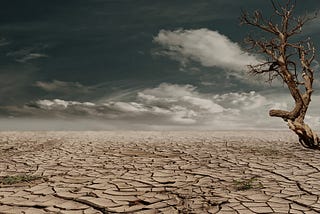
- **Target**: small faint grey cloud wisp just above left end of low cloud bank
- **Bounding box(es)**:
[34,80,91,93]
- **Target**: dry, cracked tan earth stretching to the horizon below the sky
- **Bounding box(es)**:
[0,131,320,214]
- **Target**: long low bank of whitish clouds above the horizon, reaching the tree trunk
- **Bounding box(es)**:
[0,83,304,130]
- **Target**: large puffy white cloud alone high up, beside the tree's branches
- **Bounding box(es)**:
[154,28,258,71]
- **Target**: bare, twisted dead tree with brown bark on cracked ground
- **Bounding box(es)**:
[241,0,320,149]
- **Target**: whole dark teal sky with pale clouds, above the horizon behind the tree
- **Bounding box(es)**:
[0,0,320,130]
